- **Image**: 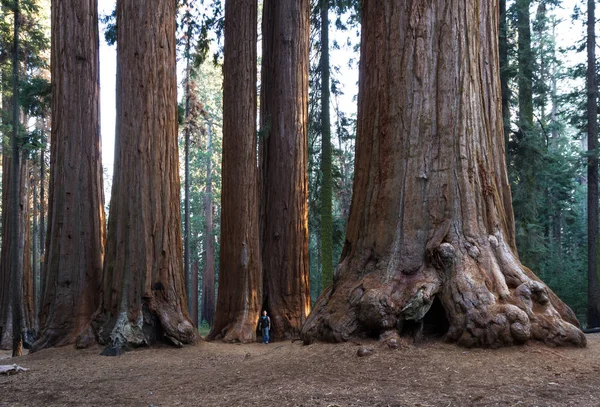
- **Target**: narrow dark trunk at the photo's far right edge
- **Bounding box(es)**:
[587,0,600,327]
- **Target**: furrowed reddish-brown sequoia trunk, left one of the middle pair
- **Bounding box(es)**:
[207,0,262,342]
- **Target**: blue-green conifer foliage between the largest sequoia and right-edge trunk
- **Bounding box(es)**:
[504,0,587,326]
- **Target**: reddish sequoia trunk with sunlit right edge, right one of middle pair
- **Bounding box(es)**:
[260,0,310,339]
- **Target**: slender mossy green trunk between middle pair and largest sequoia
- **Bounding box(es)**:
[319,0,333,288]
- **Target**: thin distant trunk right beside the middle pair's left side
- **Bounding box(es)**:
[202,121,215,326]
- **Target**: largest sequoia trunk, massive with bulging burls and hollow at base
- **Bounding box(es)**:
[302,0,586,347]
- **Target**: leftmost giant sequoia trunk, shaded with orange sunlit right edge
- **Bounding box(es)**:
[33,0,106,350]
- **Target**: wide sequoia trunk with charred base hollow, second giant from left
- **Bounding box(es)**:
[94,0,197,349]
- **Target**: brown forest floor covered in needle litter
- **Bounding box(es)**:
[0,334,600,407]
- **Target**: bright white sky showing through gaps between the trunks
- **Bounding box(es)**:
[98,0,585,191]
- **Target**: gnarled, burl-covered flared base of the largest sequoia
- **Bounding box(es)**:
[302,233,586,348]
